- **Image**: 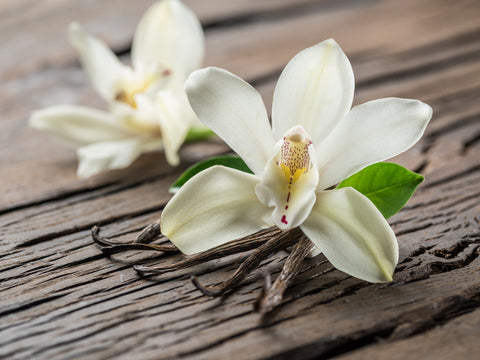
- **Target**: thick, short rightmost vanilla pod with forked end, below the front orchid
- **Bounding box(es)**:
[254,235,314,314]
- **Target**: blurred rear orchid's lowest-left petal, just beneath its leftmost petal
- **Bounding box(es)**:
[77,138,160,178]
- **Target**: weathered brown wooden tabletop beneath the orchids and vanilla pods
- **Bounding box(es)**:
[0,0,480,360]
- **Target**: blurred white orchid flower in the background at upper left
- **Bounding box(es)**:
[30,0,205,177]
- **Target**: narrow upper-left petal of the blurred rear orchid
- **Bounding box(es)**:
[69,23,129,101]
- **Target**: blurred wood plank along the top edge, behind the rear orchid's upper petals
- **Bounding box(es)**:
[0,0,318,79]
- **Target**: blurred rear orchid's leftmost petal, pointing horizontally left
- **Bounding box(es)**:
[29,105,131,146]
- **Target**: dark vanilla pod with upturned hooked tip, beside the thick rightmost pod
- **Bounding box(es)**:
[191,228,304,296]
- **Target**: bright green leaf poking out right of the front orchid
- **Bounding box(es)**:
[337,163,424,219]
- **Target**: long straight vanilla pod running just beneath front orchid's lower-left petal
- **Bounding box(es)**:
[133,227,282,275]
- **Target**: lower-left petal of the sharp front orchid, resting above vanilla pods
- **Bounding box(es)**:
[160,166,271,254]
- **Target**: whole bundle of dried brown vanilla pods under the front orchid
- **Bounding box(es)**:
[92,221,314,314]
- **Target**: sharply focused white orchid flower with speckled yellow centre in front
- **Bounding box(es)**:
[161,40,432,282]
